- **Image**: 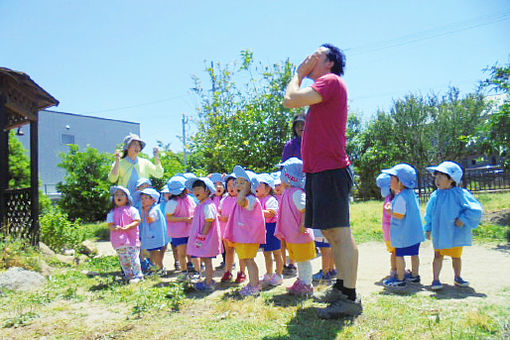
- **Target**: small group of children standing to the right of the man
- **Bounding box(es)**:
[376,161,482,290]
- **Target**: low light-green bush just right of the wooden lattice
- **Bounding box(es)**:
[40,207,85,252]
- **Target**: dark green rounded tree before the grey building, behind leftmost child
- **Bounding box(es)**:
[57,144,113,222]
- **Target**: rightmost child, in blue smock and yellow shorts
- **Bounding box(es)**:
[425,161,482,290]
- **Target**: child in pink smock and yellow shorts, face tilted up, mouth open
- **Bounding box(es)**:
[225,165,266,296]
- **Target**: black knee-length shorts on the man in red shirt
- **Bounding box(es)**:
[305,167,353,229]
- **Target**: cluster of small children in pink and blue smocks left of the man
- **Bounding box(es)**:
[107,157,336,296]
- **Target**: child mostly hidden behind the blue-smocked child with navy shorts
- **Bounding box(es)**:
[376,173,397,278]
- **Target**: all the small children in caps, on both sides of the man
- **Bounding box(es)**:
[107,157,482,296]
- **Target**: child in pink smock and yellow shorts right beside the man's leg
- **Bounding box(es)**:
[275,157,317,296]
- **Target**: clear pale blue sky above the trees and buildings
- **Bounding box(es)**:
[0,0,510,152]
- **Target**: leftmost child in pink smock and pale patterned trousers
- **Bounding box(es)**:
[106,186,143,283]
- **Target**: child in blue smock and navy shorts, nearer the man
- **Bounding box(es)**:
[382,163,425,288]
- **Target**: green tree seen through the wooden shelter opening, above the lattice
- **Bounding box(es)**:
[9,130,30,189]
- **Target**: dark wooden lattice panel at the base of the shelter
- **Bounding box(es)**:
[0,188,39,244]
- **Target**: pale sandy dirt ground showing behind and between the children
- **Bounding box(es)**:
[97,241,510,298]
